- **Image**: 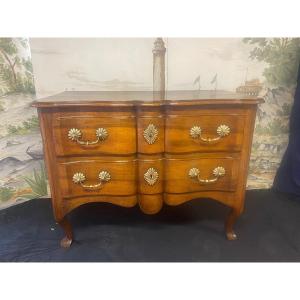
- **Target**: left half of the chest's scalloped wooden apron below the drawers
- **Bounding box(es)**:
[63,195,138,216]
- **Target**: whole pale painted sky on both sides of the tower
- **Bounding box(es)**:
[30,38,264,97]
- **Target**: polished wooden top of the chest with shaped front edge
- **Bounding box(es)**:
[33,91,263,107]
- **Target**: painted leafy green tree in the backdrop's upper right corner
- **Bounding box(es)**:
[244,38,300,88]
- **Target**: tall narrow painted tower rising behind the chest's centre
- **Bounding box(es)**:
[152,38,166,100]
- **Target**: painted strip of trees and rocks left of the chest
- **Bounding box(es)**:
[0,38,47,207]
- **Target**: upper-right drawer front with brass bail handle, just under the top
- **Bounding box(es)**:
[165,115,244,153]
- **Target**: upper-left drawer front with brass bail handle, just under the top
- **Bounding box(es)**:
[53,113,136,156]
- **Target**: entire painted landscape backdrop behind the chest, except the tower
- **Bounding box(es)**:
[0,38,300,208]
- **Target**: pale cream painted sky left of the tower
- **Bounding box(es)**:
[30,38,154,96]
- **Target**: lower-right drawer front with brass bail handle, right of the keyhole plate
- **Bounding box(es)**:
[165,158,239,194]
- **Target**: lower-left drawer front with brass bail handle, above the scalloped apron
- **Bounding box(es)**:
[59,160,137,198]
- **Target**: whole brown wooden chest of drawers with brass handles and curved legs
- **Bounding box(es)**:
[34,91,262,247]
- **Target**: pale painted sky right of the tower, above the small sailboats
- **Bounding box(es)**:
[166,38,265,90]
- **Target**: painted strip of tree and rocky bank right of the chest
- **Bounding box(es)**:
[243,38,300,188]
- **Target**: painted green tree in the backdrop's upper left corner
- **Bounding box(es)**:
[0,38,34,93]
